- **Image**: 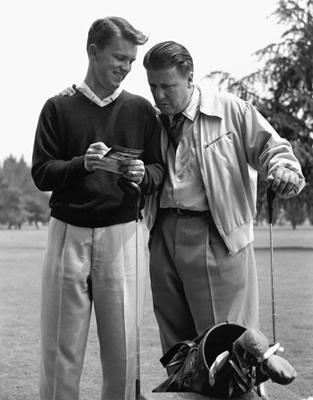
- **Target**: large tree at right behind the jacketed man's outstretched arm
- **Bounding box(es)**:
[206,0,313,228]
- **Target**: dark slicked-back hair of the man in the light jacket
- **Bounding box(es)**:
[143,41,193,76]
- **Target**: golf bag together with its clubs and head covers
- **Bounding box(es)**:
[153,322,296,398]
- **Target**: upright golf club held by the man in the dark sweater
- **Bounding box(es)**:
[117,178,141,397]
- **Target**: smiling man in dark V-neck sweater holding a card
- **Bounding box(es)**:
[32,17,164,400]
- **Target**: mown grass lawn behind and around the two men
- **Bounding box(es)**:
[0,226,313,400]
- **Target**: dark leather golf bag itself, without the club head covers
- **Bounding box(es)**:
[153,322,255,398]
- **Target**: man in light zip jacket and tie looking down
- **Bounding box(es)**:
[144,41,304,352]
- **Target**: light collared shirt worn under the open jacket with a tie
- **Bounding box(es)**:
[160,87,209,211]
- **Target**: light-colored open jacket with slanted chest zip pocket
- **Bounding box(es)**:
[145,88,305,254]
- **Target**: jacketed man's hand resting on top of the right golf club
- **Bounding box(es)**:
[268,167,302,198]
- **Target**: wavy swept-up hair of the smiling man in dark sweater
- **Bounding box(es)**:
[87,17,148,51]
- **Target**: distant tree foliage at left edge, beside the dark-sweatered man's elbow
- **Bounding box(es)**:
[0,156,49,228]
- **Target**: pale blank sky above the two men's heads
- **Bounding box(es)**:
[0,0,283,164]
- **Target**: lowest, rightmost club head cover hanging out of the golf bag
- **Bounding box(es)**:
[262,354,297,385]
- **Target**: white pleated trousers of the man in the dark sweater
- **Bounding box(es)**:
[40,218,146,400]
